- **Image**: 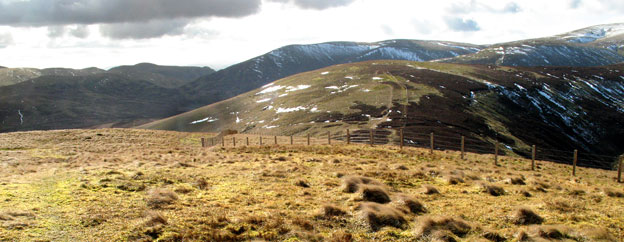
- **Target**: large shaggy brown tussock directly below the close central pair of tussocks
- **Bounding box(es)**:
[356,202,407,231]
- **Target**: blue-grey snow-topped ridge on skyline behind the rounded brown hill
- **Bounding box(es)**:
[182,40,482,110]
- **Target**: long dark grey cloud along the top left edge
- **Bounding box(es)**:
[0,0,260,26]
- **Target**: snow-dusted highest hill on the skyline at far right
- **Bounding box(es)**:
[438,24,624,66]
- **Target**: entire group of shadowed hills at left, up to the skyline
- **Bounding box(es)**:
[0,63,214,132]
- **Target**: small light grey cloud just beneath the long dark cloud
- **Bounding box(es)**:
[100,19,189,39]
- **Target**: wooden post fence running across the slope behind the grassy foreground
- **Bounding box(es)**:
[201,129,624,182]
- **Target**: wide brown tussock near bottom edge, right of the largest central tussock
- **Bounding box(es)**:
[414,217,473,238]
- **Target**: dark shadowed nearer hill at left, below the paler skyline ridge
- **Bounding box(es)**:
[0,73,182,132]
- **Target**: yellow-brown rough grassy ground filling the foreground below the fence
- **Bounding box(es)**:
[0,129,624,241]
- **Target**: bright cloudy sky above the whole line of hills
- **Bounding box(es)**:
[0,0,624,69]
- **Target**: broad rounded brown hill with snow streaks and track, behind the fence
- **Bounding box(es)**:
[143,61,624,167]
